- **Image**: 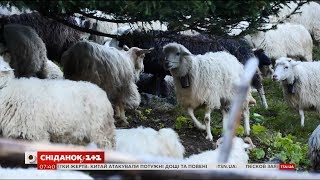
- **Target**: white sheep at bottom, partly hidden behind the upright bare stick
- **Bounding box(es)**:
[185,137,254,164]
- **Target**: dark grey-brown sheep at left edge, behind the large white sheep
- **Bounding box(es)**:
[1,24,47,77]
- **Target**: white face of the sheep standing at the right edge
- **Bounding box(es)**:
[272,57,300,81]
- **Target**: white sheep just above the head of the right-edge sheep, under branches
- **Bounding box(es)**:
[246,23,313,61]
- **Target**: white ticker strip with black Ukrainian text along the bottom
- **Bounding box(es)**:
[56,164,279,170]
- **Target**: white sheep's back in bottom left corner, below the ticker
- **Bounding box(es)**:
[0,167,93,179]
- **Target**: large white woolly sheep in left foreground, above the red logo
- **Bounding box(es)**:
[0,57,115,149]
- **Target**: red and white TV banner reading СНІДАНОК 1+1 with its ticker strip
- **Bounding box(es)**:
[25,151,295,170]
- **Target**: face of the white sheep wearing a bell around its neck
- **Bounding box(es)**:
[163,43,191,70]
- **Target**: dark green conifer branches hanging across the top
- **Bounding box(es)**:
[1,0,308,35]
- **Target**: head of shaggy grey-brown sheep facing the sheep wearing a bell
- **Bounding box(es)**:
[128,47,153,80]
